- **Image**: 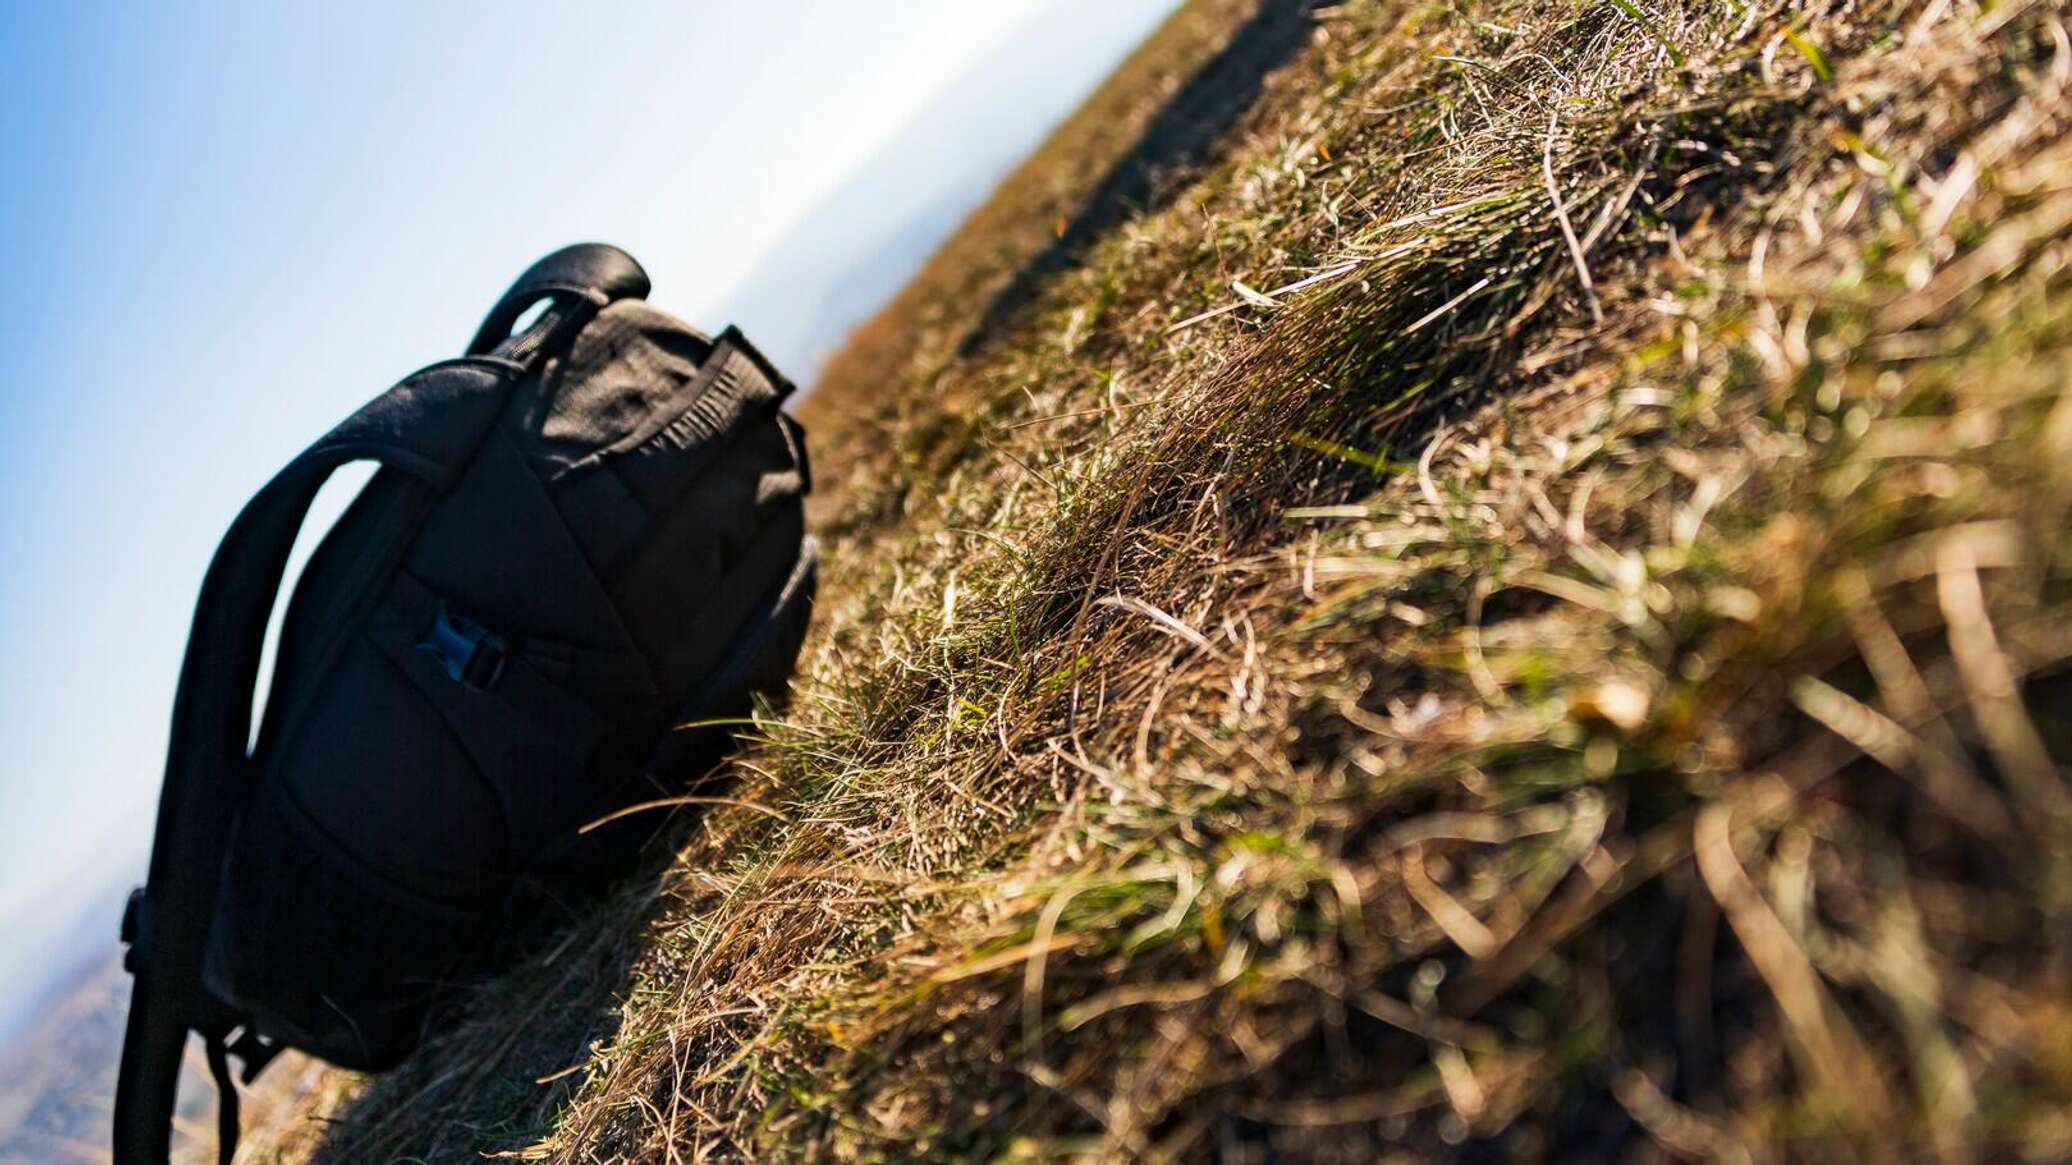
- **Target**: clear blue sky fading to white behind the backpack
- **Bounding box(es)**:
[0,0,1171,1030]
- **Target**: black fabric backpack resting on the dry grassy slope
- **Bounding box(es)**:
[114,245,814,1165]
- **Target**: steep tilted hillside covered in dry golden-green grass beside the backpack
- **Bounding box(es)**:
[267,0,2072,1163]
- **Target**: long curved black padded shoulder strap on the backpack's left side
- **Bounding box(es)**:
[114,361,516,1165]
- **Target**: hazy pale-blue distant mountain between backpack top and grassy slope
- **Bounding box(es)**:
[725,0,1173,383]
